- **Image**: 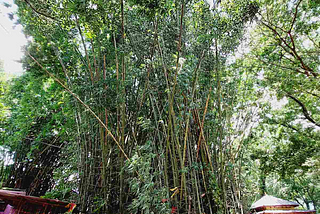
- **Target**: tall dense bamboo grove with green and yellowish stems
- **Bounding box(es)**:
[0,0,318,214]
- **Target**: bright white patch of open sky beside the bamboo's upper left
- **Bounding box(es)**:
[0,0,27,75]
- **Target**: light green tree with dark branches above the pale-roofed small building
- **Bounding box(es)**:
[242,1,319,211]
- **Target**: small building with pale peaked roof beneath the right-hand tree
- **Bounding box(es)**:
[250,195,316,214]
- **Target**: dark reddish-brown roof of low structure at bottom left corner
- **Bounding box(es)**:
[0,190,76,214]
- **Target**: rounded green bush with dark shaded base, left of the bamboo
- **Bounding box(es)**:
[2,70,71,195]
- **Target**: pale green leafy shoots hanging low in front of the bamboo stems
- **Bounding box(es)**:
[124,141,170,214]
